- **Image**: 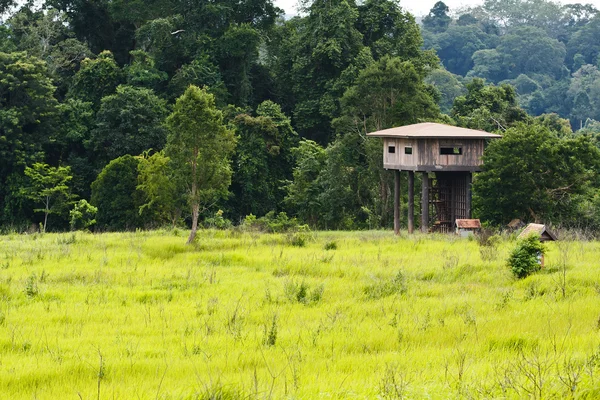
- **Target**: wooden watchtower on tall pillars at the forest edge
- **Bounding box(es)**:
[367,122,501,233]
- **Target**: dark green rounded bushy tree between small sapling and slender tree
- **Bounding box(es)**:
[91,154,143,230]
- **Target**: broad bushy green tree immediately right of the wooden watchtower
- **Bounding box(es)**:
[473,124,600,224]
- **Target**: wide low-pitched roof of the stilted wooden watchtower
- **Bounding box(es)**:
[367,122,502,139]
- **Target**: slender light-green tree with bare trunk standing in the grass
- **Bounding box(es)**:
[165,86,235,244]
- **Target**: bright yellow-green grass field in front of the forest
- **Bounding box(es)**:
[0,231,600,399]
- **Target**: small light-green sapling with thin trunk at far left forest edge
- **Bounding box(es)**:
[21,163,73,232]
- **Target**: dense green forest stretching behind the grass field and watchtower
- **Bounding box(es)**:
[0,0,600,232]
